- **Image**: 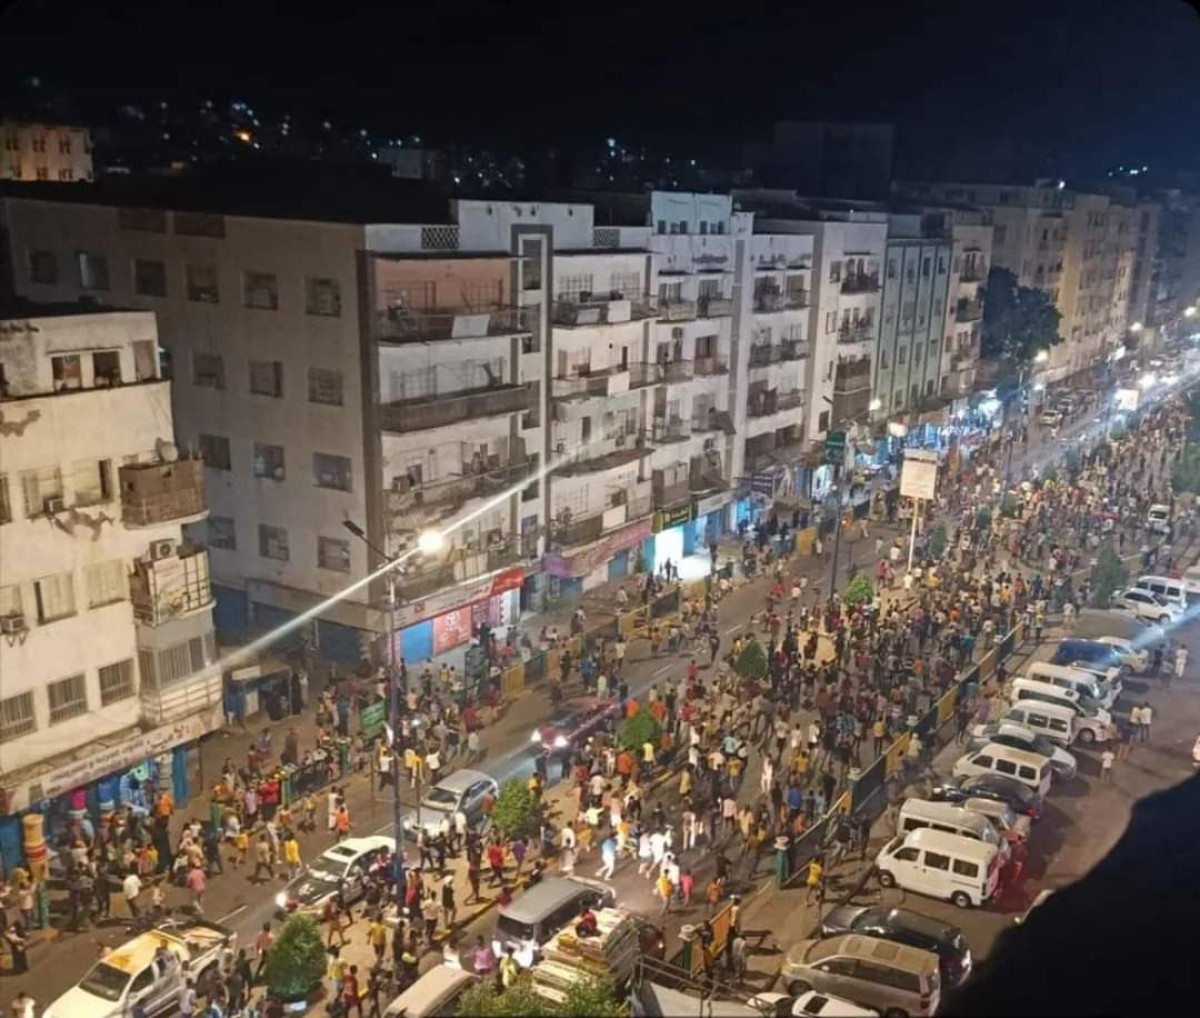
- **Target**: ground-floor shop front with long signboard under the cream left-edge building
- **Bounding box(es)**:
[0,705,224,873]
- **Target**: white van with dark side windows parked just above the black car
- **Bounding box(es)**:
[875,831,1001,909]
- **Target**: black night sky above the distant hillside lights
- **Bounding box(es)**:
[0,0,1200,174]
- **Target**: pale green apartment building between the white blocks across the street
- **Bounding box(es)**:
[874,212,955,415]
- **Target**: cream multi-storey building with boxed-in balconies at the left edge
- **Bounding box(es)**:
[0,301,224,845]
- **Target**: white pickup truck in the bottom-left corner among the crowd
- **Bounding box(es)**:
[42,917,238,1018]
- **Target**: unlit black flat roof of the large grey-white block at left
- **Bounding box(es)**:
[0,160,451,224]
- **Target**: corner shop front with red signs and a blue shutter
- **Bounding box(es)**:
[395,567,526,663]
